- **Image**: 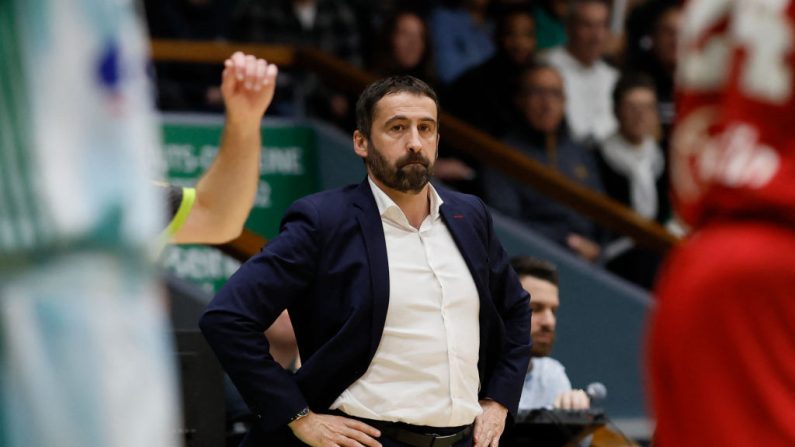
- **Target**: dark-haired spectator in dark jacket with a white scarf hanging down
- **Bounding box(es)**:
[596,74,671,288]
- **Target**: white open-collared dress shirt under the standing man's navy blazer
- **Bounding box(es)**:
[331,180,481,427]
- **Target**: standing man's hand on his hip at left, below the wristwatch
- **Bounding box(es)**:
[288,411,381,447]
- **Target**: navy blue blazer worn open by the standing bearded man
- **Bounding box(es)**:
[199,179,530,445]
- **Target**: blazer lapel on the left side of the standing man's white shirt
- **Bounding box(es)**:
[354,178,389,358]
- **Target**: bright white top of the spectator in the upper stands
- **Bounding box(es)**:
[545,47,618,141]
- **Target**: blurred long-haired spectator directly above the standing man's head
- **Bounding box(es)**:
[372,11,436,84]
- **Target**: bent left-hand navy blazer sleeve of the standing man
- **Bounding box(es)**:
[199,200,319,431]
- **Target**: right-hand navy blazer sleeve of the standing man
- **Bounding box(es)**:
[483,200,531,415]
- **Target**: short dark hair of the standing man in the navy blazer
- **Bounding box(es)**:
[356,75,439,138]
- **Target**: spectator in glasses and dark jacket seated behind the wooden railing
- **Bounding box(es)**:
[483,64,603,261]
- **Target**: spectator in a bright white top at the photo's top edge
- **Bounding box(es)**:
[545,0,618,141]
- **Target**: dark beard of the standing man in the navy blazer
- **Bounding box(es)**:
[365,139,433,193]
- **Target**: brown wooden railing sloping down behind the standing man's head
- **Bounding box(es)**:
[152,40,678,254]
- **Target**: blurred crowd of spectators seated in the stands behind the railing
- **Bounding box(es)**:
[145,0,681,287]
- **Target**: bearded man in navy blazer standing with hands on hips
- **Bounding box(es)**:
[200,76,530,446]
